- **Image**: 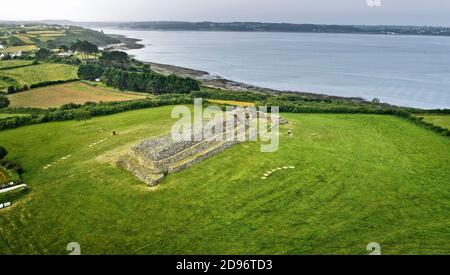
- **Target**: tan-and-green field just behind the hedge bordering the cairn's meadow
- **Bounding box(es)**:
[8,82,145,109]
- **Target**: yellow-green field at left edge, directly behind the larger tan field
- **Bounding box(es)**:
[0,63,78,86]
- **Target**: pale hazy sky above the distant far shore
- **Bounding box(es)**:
[0,0,450,26]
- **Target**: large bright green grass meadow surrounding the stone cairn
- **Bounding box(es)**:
[0,107,450,254]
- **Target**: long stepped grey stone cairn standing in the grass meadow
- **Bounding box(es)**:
[117,108,282,187]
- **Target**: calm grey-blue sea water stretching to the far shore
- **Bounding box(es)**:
[102,30,450,108]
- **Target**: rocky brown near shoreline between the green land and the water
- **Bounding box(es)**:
[111,33,394,107]
